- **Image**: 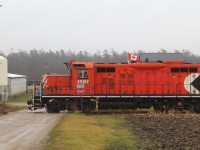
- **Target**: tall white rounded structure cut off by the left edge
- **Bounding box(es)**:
[0,56,8,100]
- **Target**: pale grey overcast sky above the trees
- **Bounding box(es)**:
[0,0,200,55]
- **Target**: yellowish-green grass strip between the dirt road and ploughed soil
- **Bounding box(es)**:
[46,113,153,150]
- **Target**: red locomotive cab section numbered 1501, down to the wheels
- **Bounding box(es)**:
[66,61,97,112]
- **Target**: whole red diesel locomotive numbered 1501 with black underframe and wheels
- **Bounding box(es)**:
[27,60,200,112]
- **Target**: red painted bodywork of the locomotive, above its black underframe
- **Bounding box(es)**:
[42,61,200,96]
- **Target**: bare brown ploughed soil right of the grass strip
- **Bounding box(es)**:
[117,113,200,150]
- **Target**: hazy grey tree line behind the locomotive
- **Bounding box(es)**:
[0,49,200,80]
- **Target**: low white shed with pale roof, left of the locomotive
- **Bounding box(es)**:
[8,73,27,97]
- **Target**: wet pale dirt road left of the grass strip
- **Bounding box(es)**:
[0,110,66,150]
